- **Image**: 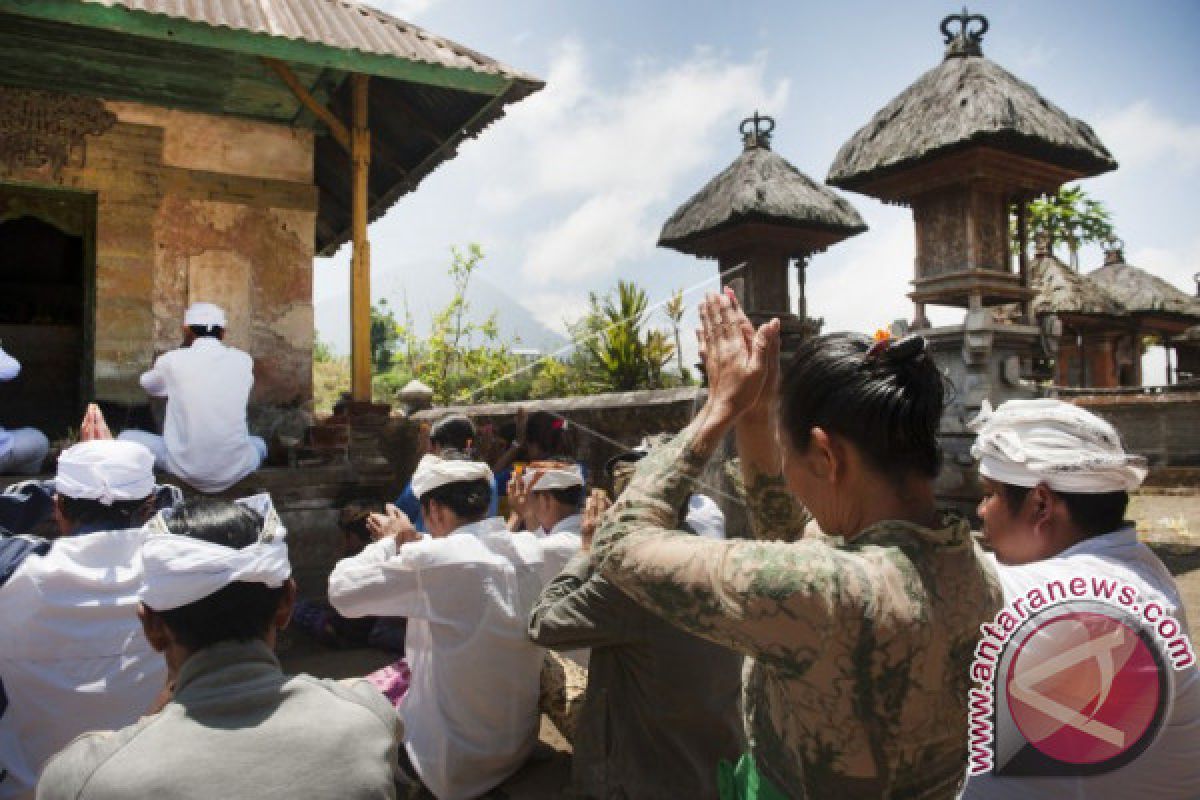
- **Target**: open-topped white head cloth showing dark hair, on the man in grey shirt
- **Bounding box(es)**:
[138,494,292,612]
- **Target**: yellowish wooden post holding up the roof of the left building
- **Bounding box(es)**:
[350,74,371,403]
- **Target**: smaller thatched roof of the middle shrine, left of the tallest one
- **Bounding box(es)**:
[659,116,866,255]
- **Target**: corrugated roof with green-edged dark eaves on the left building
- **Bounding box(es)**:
[0,0,544,254]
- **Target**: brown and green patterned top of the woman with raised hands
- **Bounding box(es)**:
[593,431,1002,800]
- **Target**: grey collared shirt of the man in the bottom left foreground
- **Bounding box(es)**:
[37,642,400,800]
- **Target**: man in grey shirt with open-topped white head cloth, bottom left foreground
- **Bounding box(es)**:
[37,495,400,800]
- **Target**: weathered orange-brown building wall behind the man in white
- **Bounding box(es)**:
[4,95,317,405]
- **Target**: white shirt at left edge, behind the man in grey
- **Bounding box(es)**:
[0,528,167,800]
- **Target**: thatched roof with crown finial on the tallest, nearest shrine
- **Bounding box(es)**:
[826,10,1117,190]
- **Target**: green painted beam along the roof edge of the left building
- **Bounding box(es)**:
[0,0,509,96]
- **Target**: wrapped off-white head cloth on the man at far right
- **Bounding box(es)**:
[971,399,1146,494]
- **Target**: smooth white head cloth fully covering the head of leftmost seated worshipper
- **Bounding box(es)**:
[54,439,154,505]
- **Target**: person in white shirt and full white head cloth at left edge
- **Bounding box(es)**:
[0,439,167,800]
